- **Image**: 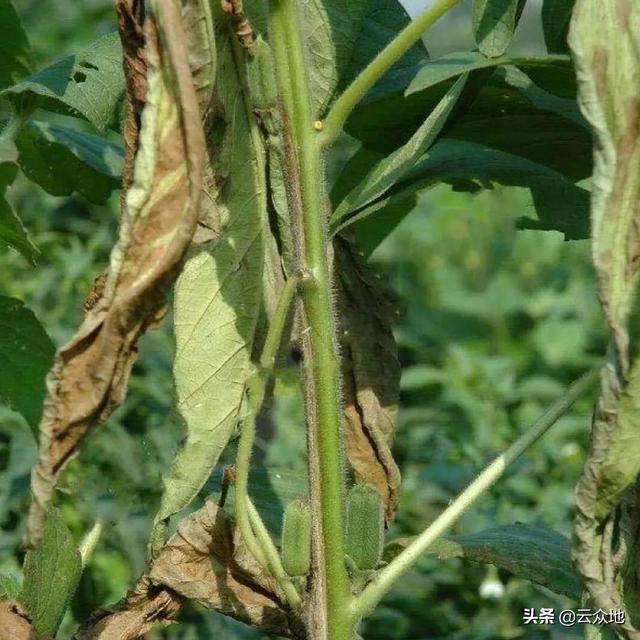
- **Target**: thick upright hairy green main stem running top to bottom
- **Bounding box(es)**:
[270,0,352,640]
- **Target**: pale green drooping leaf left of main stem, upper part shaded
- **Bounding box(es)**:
[154,21,266,545]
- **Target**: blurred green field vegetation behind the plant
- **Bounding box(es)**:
[0,0,606,640]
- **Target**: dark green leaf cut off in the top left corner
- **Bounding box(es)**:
[0,0,33,89]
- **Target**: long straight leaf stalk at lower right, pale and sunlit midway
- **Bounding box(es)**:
[350,367,600,621]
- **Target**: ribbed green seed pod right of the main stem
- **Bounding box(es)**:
[347,483,384,571]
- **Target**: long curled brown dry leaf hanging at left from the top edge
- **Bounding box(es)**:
[27,2,206,546]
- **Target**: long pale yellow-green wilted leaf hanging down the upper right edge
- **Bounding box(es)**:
[571,0,640,361]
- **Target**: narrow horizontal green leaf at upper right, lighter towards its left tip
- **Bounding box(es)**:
[405,51,574,96]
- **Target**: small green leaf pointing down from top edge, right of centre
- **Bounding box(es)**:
[472,0,526,58]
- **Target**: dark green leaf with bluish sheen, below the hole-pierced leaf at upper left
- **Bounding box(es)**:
[16,121,124,204]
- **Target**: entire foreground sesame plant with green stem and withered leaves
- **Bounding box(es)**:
[0,0,640,640]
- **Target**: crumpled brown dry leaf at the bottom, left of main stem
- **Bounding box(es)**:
[76,502,298,640]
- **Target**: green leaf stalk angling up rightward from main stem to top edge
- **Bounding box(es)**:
[319,0,462,146]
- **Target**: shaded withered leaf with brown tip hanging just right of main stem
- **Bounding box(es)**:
[334,236,400,524]
